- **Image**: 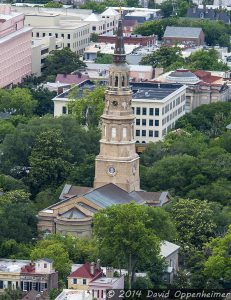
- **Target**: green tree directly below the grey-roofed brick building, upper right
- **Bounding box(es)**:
[140,46,183,69]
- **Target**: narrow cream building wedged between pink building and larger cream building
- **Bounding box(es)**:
[32,36,63,76]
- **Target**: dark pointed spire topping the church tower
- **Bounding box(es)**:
[113,10,126,64]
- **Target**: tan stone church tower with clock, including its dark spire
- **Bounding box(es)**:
[94,18,140,192]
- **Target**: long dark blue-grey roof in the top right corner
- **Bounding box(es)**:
[187,7,230,24]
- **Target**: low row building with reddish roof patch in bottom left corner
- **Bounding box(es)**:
[0,258,58,292]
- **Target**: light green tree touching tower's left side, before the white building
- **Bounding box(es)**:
[69,86,105,127]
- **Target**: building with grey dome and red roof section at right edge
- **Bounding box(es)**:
[154,69,231,112]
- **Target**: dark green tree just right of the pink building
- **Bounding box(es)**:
[42,48,85,77]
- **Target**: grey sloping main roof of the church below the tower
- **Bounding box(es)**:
[84,183,141,208]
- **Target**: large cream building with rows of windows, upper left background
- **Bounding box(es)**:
[25,12,90,54]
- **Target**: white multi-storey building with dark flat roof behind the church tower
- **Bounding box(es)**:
[53,81,186,144]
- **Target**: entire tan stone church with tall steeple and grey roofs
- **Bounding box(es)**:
[38,19,170,236]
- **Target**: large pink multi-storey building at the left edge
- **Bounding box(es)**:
[0,4,32,88]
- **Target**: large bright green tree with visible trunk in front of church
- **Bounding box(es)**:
[93,202,174,288]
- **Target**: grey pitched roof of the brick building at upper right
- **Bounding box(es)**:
[164,26,202,38]
